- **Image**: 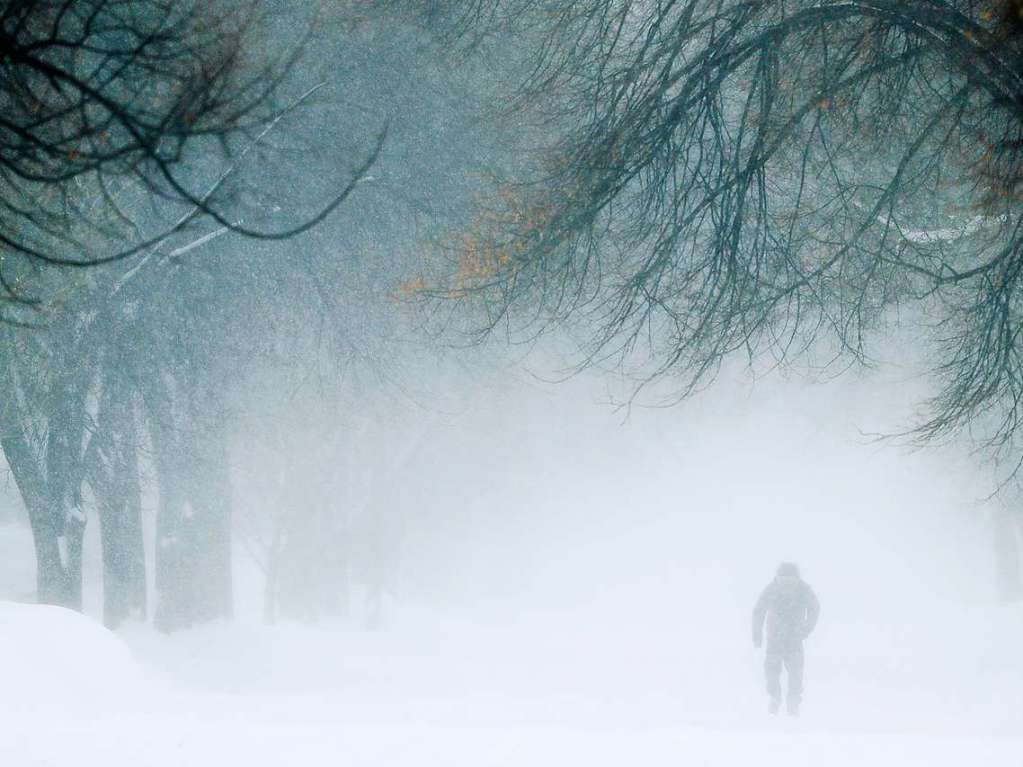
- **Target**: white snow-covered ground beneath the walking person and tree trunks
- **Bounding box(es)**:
[0,605,1023,767]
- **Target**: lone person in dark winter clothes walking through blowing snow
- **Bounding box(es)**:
[753,562,820,716]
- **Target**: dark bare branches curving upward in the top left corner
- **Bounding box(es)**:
[0,0,379,319]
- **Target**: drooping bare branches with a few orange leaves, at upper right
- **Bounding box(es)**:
[428,0,1023,456]
